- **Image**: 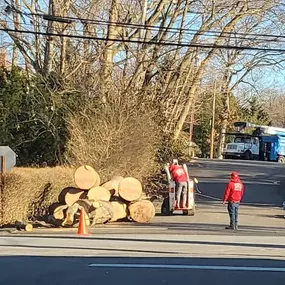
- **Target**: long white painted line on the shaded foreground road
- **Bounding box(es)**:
[89,263,285,272]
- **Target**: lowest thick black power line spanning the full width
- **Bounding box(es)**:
[0,28,285,53]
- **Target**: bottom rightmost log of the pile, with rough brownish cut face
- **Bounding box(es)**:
[128,200,155,223]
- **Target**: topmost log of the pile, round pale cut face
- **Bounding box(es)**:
[74,165,100,190]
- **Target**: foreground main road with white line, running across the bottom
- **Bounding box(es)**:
[0,234,285,285]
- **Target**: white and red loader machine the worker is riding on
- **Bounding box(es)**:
[161,164,198,216]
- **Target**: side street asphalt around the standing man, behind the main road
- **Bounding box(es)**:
[111,159,285,236]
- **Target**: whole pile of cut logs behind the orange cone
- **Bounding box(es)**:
[49,165,155,227]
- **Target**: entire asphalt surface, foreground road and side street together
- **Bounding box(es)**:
[0,160,285,285]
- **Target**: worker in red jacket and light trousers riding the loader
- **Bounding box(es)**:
[169,159,188,208]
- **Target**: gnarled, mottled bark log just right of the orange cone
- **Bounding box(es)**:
[89,201,114,226]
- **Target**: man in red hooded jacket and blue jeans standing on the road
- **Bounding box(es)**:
[223,172,244,230]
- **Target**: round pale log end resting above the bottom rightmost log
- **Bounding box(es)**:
[119,177,142,202]
